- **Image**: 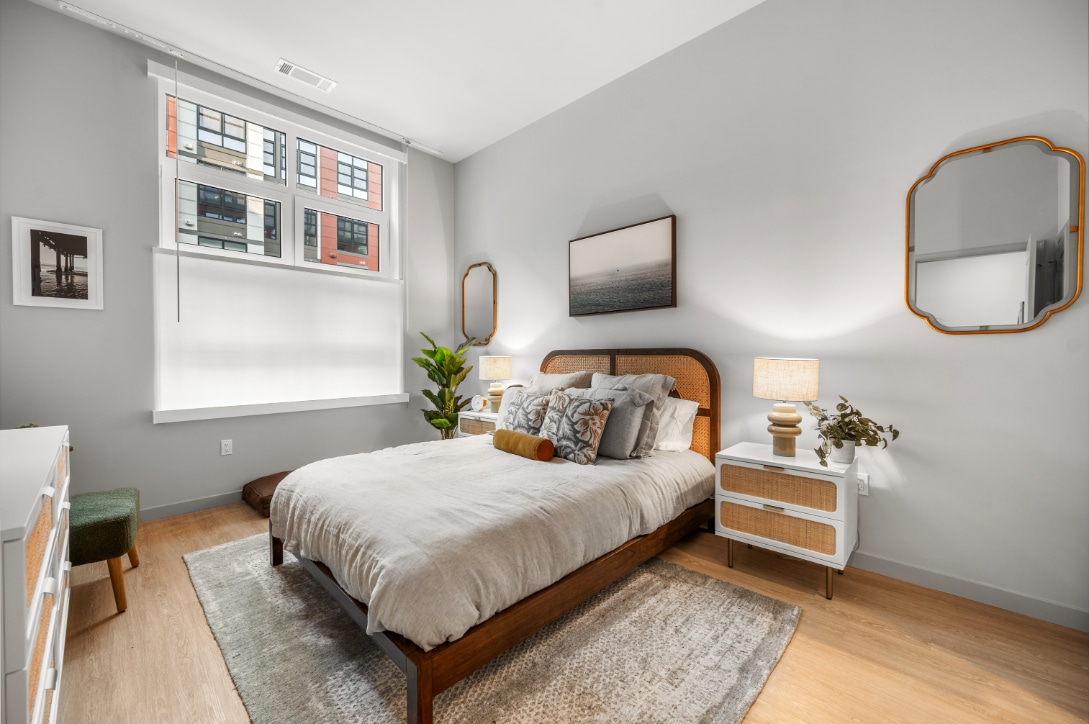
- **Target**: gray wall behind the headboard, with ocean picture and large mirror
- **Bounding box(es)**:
[455,0,1089,628]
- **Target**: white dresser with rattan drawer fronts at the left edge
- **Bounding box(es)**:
[0,426,72,724]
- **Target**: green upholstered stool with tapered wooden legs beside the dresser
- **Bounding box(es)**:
[69,488,139,613]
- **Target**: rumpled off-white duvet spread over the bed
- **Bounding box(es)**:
[271,435,714,650]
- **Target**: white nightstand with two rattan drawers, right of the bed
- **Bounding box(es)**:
[714,442,858,599]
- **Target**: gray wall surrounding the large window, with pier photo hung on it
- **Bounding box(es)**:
[0,0,456,518]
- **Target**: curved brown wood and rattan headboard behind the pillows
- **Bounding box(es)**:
[541,347,721,463]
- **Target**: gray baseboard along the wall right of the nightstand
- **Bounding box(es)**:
[851,551,1089,633]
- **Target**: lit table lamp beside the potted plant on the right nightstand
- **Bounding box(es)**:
[752,357,820,457]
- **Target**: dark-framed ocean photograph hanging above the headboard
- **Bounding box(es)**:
[567,216,677,317]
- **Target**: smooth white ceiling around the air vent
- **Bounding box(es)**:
[44,0,762,161]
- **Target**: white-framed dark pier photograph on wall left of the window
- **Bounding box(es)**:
[11,217,102,309]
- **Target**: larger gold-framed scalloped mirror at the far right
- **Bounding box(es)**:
[906,136,1085,334]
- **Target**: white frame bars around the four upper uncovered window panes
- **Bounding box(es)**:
[148,61,407,280]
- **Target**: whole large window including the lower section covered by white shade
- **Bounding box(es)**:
[148,61,408,422]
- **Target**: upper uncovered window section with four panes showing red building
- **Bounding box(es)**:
[160,83,400,274]
